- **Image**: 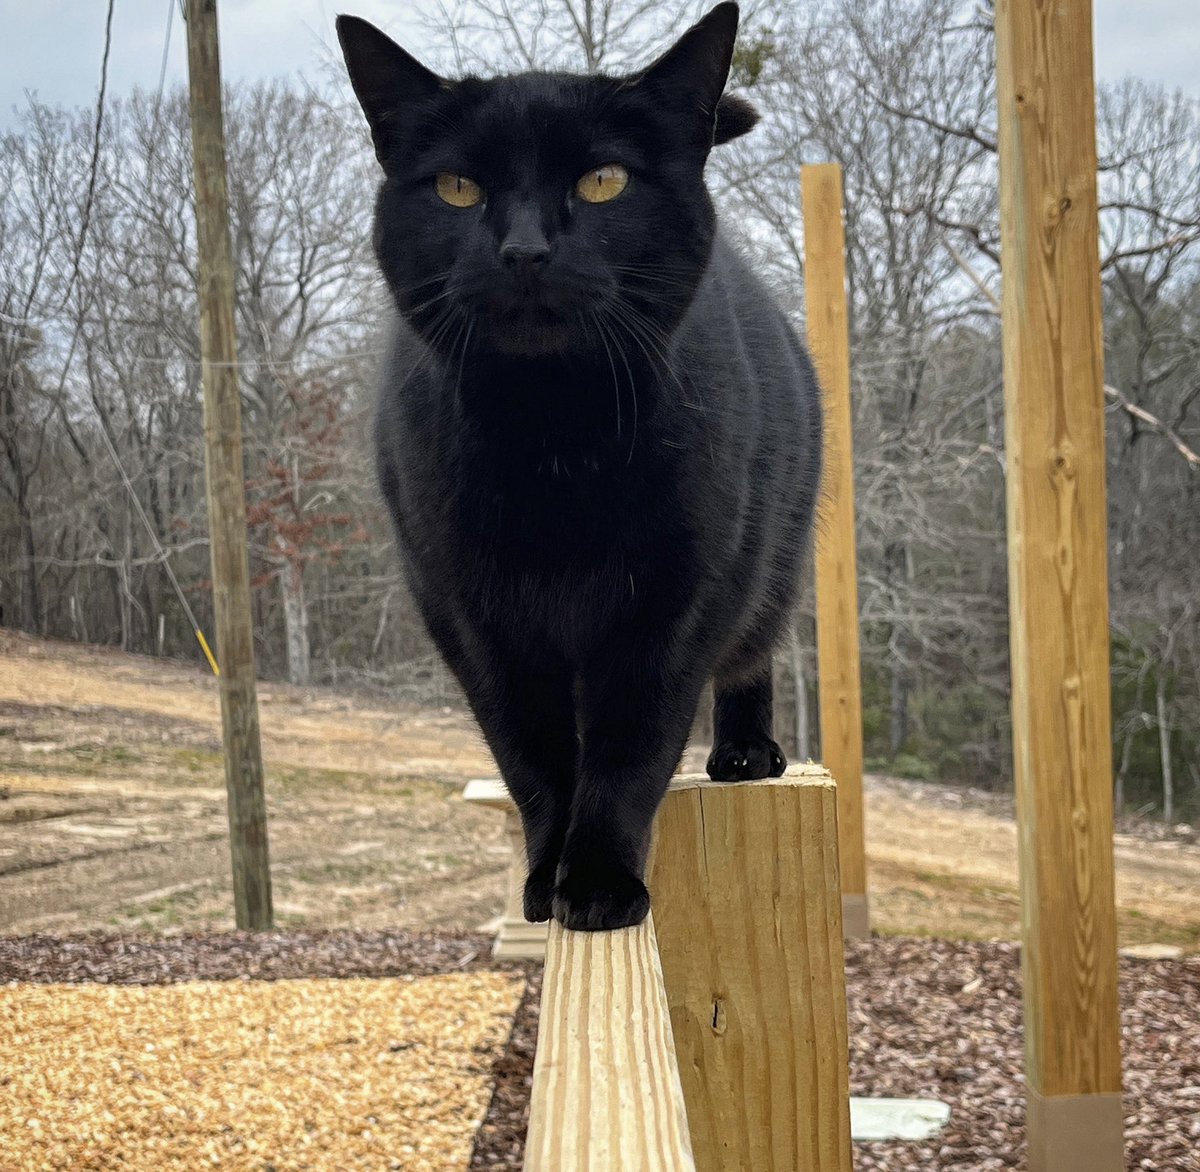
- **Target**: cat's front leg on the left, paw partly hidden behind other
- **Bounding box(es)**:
[430,611,578,922]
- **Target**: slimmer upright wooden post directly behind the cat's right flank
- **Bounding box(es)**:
[800,163,870,938]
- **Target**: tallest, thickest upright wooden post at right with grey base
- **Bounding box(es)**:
[996,0,1124,1172]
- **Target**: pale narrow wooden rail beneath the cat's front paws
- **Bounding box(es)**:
[524,919,696,1172]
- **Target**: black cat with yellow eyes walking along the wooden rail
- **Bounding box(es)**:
[337,4,821,928]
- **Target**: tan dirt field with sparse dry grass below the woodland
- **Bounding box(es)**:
[0,631,1200,951]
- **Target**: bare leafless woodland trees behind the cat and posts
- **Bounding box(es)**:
[0,0,1200,821]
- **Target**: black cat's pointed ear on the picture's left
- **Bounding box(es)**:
[337,17,450,164]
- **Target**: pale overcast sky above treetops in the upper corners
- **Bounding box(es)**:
[0,0,1200,126]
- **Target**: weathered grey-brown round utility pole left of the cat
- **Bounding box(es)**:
[187,0,272,928]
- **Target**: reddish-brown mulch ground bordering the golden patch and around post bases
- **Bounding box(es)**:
[0,932,1200,1172]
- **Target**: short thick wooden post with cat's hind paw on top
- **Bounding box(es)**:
[648,765,851,1172]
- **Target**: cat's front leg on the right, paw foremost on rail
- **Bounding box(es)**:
[553,645,703,931]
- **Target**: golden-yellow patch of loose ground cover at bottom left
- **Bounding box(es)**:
[0,973,524,1172]
